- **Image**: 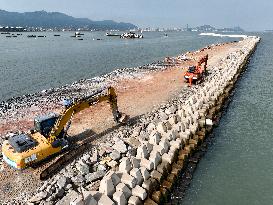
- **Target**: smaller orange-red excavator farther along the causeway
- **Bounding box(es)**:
[184,54,208,86]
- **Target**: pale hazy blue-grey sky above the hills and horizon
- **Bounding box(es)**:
[0,0,273,31]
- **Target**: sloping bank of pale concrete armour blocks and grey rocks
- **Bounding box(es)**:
[23,37,260,204]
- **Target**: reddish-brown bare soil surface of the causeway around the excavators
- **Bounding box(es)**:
[0,39,238,203]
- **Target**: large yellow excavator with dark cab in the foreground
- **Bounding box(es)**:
[2,87,128,169]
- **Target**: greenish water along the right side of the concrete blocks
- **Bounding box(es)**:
[174,33,273,205]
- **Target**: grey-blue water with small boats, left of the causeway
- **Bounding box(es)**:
[0,32,235,101]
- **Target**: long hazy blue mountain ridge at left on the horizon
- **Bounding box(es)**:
[0,10,137,30]
